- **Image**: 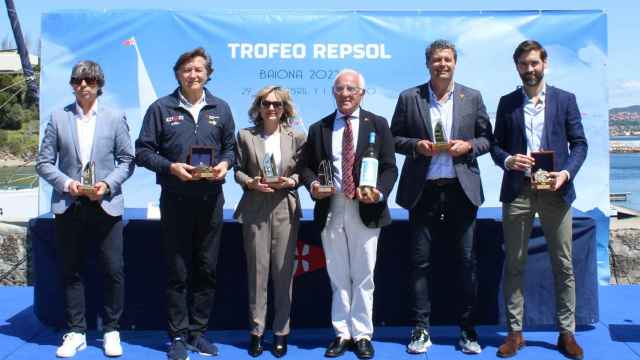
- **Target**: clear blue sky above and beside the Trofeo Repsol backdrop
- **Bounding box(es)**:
[0,0,640,108]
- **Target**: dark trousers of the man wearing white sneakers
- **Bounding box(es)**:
[55,198,124,333]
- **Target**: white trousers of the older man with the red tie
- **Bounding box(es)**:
[320,193,380,341]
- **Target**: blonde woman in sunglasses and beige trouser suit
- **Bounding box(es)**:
[234,86,305,357]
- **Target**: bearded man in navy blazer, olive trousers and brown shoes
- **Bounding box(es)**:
[491,40,587,359]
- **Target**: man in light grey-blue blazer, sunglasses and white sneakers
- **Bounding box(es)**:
[36,61,134,357]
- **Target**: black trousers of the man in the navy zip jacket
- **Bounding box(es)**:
[160,190,224,340]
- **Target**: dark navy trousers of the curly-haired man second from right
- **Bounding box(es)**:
[409,181,478,330]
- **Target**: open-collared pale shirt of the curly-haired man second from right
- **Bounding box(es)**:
[427,85,456,180]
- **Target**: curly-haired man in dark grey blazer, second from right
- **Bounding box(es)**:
[391,40,491,353]
